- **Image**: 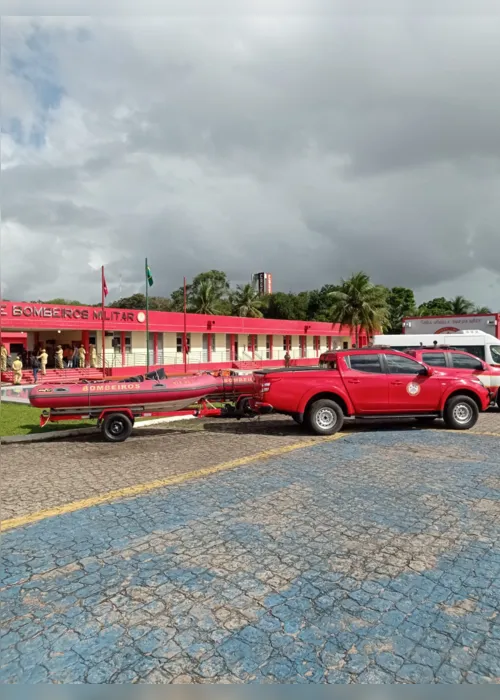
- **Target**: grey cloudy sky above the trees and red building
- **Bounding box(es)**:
[1,0,500,310]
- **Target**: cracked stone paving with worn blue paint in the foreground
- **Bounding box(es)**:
[0,430,500,683]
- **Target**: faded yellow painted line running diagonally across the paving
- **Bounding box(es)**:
[0,433,346,530]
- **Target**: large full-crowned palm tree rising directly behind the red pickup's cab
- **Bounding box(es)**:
[329,272,389,346]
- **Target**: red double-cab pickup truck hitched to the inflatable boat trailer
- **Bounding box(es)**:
[254,349,491,435]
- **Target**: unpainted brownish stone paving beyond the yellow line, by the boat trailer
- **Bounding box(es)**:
[1,412,500,520]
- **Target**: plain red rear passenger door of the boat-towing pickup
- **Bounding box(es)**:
[340,352,389,414]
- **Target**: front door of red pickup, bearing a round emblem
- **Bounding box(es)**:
[386,355,442,413]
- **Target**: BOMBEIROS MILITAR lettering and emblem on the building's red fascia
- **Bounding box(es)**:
[0,302,145,323]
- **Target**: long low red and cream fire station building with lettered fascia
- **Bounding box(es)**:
[0,301,367,375]
